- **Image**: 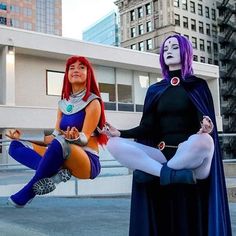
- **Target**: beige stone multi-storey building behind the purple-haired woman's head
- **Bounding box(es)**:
[115,0,218,64]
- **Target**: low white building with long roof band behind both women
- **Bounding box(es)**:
[0,26,222,164]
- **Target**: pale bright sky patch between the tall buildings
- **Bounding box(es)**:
[62,0,117,39]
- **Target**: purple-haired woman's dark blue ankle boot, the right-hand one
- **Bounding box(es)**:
[160,163,197,185]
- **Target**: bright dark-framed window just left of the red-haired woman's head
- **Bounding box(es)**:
[46,70,64,96]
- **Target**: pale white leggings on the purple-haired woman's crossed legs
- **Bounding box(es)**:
[107,133,214,179]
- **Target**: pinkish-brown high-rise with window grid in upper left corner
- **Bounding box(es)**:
[0,0,62,36]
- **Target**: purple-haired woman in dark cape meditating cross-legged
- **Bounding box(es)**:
[103,35,232,236]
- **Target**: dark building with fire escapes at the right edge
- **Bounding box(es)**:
[217,0,236,158]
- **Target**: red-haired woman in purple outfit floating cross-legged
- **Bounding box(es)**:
[7,56,107,207]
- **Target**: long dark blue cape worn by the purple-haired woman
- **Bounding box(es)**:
[129,76,232,236]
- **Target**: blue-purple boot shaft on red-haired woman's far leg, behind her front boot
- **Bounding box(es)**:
[8,140,42,170]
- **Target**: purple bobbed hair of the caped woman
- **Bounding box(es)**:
[160,34,193,79]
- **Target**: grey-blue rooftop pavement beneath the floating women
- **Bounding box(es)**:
[0,197,236,236]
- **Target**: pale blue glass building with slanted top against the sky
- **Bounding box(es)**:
[82,11,119,46]
